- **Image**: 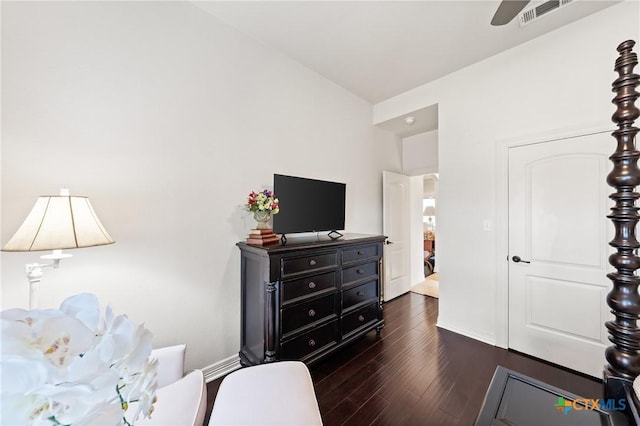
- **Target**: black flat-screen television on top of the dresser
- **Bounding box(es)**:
[273,174,346,234]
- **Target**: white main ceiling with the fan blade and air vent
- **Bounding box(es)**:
[194,0,616,105]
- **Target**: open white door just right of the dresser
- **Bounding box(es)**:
[382,171,411,301]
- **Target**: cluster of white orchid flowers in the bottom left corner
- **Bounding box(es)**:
[0,293,157,426]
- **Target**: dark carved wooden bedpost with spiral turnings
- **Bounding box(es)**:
[604,40,640,399]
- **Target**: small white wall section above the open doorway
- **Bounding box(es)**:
[402,130,438,176]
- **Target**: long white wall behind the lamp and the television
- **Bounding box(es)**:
[1,2,401,368]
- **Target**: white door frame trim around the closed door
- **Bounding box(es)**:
[495,123,616,349]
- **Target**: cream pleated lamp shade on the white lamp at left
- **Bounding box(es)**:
[2,195,114,251]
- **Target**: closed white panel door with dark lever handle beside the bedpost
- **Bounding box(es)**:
[509,133,615,377]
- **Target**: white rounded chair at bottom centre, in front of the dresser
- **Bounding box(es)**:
[209,361,322,426]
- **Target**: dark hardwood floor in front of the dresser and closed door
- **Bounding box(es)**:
[205,293,602,426]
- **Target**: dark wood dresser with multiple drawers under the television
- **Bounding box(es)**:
[237,234,385,366]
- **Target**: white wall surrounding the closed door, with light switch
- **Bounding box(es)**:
[374,2,640,342]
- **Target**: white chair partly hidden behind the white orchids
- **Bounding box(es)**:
[136,345,207,426]
